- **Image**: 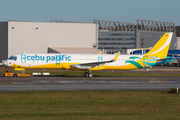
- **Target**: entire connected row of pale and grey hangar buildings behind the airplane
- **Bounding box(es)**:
[0,20,180,59]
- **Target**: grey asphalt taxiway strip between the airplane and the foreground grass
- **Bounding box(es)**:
[0,76,180,91]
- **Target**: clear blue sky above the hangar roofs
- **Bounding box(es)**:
[0,0,180,26]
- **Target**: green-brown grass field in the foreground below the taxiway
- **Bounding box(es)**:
[0,91,180,120]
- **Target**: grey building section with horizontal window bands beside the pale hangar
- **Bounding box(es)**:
[93,20,136,54]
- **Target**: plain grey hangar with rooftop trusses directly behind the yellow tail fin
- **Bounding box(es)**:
[136,20,177,50]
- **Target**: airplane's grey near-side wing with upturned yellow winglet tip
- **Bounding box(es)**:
[70,52,120,69]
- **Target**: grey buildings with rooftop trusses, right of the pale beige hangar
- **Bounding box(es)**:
[93,20,177,54]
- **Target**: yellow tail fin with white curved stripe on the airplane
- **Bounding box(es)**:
[144,32,173,59]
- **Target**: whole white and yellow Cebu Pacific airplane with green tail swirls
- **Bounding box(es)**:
[3,32,173,77]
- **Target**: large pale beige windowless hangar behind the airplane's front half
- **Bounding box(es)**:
[0,21,100,59]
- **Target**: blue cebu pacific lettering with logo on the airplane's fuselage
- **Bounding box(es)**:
[21,54,71,63]
